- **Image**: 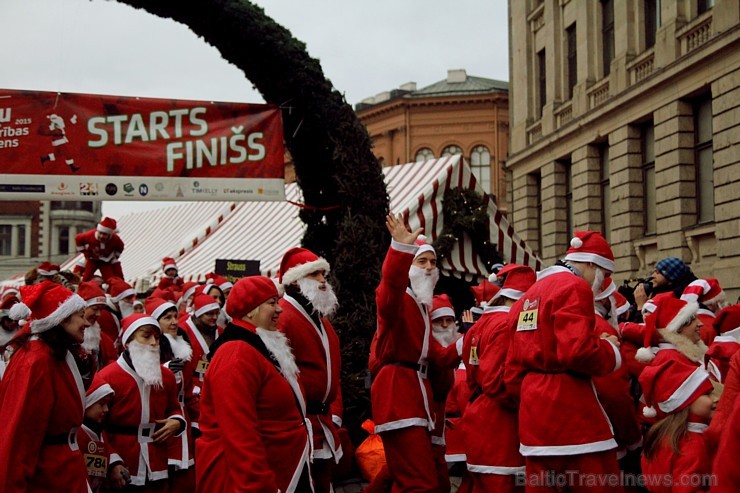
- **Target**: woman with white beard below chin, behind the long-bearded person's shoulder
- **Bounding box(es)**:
[145,298,198,493]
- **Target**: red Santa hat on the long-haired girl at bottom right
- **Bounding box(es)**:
[639,359,713,418]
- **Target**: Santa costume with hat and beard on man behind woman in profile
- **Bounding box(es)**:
[278,248,342,492]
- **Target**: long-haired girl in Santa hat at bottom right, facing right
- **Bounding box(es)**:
[640,359,718,493]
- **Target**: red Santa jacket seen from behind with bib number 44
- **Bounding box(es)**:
[505,266,622,456]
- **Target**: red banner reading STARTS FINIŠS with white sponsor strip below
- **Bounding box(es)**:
[0,89,284,200]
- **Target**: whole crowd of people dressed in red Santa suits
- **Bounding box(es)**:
[0,215,740,493]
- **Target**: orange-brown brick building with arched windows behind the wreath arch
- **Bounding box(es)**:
[355,70,509,212]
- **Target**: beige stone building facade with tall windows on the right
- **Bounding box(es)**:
[506,0,740,301]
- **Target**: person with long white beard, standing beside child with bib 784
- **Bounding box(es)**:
[98,314,186,492]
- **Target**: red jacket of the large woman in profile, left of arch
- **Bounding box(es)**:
[195,320,309,492]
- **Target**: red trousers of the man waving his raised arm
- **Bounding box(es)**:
[380,426,438,493]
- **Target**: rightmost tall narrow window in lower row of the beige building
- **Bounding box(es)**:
[694,95,714,223]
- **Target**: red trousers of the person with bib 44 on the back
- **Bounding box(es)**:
[525,450,623,493]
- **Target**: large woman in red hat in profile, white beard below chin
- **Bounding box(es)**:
[195,276,313,493]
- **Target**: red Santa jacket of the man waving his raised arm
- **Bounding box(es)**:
[370,241,461,433]
